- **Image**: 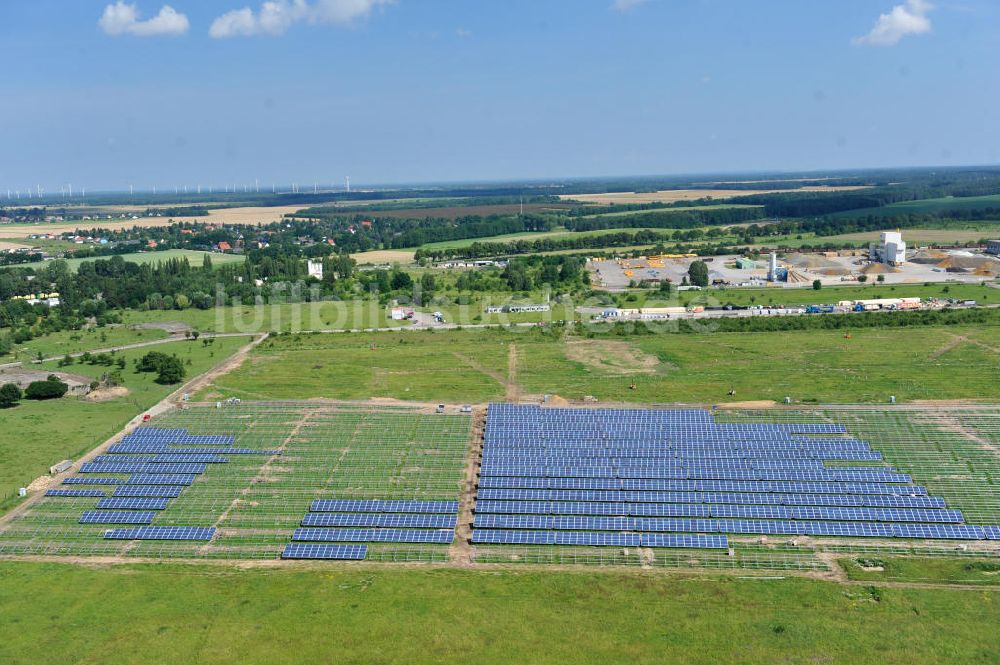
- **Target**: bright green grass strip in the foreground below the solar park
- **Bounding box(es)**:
[0,562,1000,665]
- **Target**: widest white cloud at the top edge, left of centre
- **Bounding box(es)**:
[208,0,396,39]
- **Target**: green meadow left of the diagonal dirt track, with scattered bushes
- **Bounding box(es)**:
[0,337,247,507]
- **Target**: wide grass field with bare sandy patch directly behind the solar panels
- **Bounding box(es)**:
[201,326,1000,403]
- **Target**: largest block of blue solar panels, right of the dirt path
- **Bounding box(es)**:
[473,404,1000,548]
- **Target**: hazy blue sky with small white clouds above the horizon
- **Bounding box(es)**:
[0,0,1000,192]
